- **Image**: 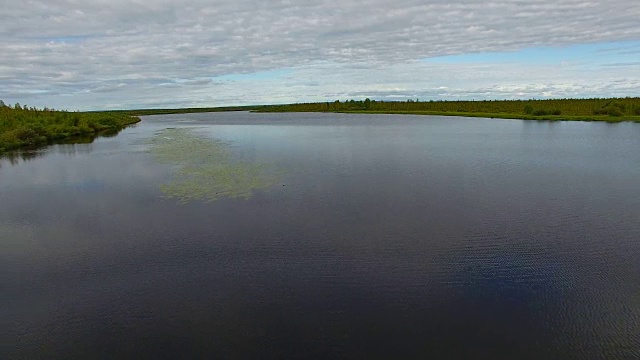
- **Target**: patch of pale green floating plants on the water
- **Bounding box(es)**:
[149,128,279,203]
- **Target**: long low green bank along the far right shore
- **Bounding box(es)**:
[257,97,640,122]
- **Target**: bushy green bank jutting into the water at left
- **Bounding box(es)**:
[0,105,140,153]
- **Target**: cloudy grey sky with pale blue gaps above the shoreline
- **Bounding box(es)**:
[0,0,640,110]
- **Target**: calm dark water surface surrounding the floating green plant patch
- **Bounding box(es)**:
[0,113,640,359]
